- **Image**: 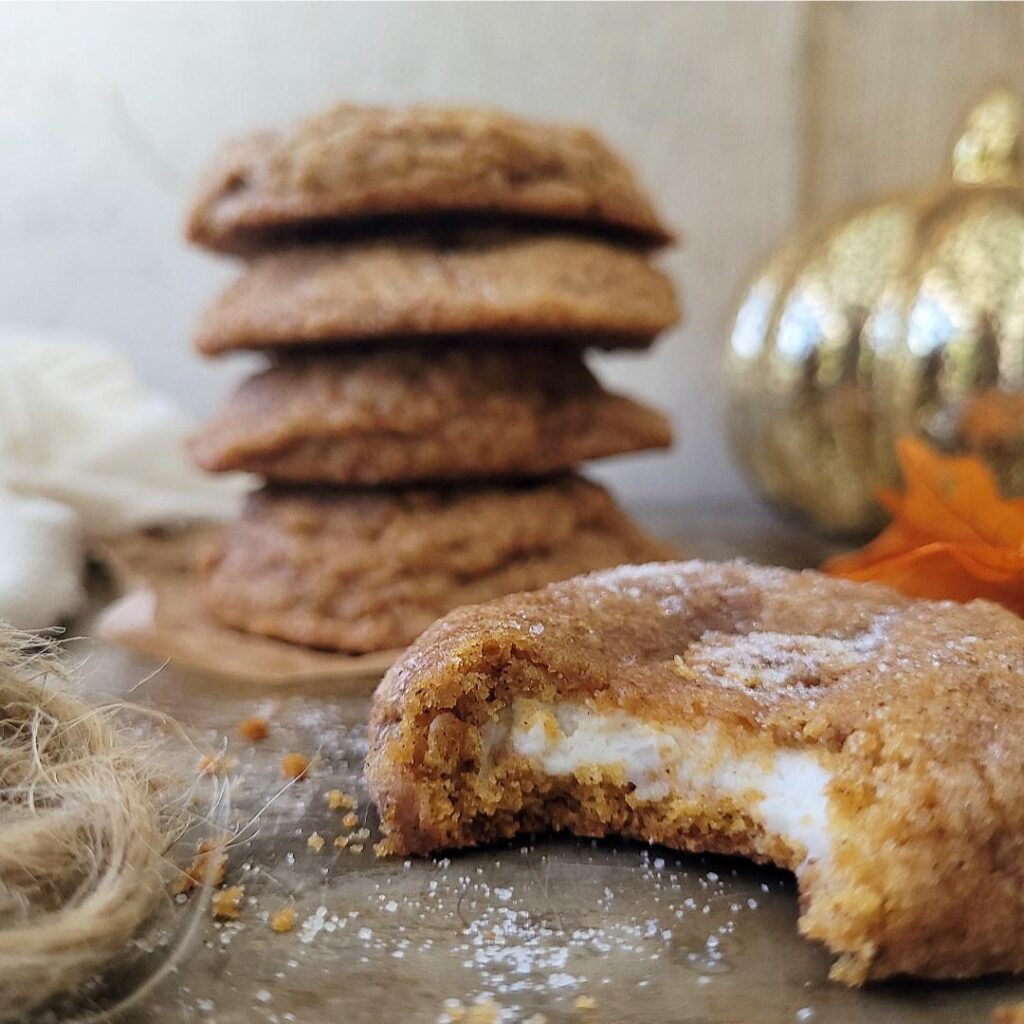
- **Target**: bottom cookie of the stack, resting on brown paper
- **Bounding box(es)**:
[199,475,676,653]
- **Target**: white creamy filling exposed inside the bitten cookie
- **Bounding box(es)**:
[484,697,830,866]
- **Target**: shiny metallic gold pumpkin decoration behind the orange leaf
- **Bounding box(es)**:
[726,90,1024,535]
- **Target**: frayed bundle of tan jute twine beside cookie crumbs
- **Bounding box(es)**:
[0,625,226,1022]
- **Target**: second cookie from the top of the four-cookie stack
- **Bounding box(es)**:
[196,232,680,355]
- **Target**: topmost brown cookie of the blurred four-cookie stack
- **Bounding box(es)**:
[187,104,671,251]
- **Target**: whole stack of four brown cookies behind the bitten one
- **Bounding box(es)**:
[188,99,679,653]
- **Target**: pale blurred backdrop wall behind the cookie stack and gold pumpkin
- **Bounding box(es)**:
[0,3,1024,501]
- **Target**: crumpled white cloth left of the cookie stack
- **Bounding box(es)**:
[0,329,247,629]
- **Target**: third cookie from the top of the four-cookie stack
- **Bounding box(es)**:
[191,347,672,484]
